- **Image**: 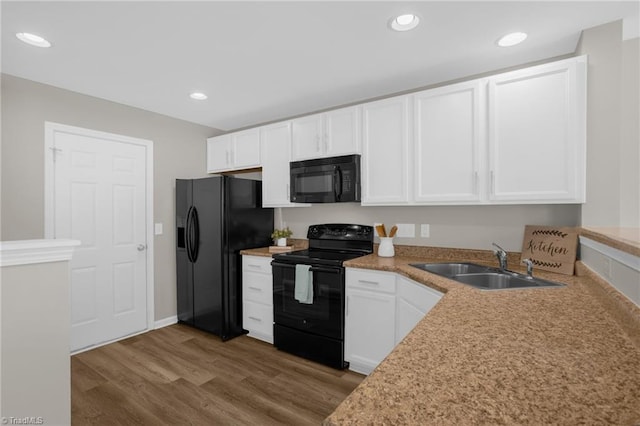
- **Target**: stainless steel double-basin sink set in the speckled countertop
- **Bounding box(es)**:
[411,263,565,290]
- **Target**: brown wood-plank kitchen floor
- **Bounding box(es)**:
[71,324,364,425]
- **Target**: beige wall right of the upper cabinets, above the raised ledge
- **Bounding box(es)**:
[577,21,640,227]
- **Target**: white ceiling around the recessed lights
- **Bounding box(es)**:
[1,1,640,130]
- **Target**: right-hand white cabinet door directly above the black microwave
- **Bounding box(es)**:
[323,107,362,157]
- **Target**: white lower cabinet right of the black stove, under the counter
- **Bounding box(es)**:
[344,268,442,374]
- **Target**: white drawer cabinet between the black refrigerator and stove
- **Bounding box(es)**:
[242,255,273,343]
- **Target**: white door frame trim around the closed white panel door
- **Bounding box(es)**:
[44,121,155,340]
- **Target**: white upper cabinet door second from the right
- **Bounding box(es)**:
[413,80,482,203]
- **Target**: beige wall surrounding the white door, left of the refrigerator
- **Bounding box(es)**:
[1,75,221,320]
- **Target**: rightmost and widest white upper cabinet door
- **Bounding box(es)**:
[489,57,586,202]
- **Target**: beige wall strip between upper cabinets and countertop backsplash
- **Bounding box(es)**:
[276,203,580,251]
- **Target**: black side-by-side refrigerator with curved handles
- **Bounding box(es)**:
[176,176,273,340]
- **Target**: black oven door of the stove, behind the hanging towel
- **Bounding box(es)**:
[271,261,344,340]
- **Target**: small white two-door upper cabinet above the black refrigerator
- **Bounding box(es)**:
[207,128,260,173]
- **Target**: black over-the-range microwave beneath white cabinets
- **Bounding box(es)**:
[290,154,360,203]
